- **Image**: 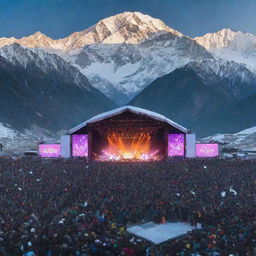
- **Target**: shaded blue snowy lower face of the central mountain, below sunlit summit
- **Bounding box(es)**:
[66,33,212,103]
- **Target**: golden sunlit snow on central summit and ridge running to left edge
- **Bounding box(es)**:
[0,12,183,51]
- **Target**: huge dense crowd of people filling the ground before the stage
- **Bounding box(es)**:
[0,158,256,256]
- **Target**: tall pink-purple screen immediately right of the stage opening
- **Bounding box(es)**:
[168,134,185,157]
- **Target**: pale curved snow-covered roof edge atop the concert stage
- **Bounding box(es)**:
[67,105,189,134]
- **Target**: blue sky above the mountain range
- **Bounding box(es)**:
[0,0,256,38]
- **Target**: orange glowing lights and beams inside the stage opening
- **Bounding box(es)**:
[100,133,157,160]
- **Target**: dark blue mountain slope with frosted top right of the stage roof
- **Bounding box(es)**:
[130,60,256,137]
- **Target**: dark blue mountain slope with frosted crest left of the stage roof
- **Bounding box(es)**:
[0,51,115,134]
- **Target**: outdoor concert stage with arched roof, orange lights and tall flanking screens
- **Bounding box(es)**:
[57,106,195,161]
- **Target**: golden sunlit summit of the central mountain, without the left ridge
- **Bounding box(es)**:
[58,12,183,48]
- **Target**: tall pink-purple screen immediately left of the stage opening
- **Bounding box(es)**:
[72,134,88,157]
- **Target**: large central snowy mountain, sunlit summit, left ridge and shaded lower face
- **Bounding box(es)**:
[0,12,213,103]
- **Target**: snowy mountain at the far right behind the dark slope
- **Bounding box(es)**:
[194,28,256,72]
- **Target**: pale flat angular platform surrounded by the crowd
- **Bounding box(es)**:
[127,222,201,244]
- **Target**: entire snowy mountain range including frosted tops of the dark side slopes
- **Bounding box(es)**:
[0,12,256,104]
